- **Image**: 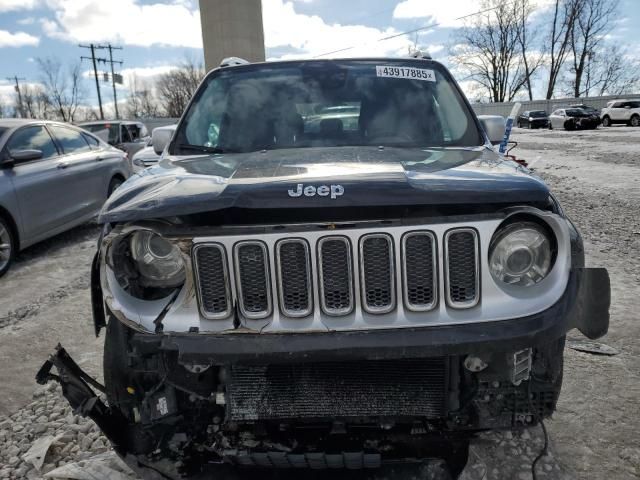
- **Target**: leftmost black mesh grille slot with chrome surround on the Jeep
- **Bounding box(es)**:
[192,243,233,320]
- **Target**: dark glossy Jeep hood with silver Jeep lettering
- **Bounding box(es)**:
[100,147,549,223]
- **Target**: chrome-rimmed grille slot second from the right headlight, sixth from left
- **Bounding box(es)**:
[401,230,439,312]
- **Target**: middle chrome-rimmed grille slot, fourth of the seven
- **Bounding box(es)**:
[318,235,355,316]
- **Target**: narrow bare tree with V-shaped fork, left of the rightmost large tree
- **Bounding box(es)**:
[546,0,584,100]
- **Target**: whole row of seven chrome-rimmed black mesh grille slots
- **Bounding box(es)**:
[193,228,480,319]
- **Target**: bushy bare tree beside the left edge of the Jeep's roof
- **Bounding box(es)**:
[156,59,205,117]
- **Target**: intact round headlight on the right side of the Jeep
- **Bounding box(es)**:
[489,222,552,287]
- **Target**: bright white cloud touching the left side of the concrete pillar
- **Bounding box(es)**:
[41,0,202,48]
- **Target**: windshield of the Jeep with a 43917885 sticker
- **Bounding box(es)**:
[172,60,484,154]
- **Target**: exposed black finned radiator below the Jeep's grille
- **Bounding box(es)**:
[227,357,448,421]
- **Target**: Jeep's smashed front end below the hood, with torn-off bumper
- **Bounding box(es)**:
[38,209,609,479]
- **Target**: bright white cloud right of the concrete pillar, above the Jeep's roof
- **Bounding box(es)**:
[262,0,418,60]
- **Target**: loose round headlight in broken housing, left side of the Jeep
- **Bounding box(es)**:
[109,229,185,300]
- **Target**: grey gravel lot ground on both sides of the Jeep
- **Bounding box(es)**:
[0,127,640,480]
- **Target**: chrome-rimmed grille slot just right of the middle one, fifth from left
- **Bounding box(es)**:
[359,233,396,314]
